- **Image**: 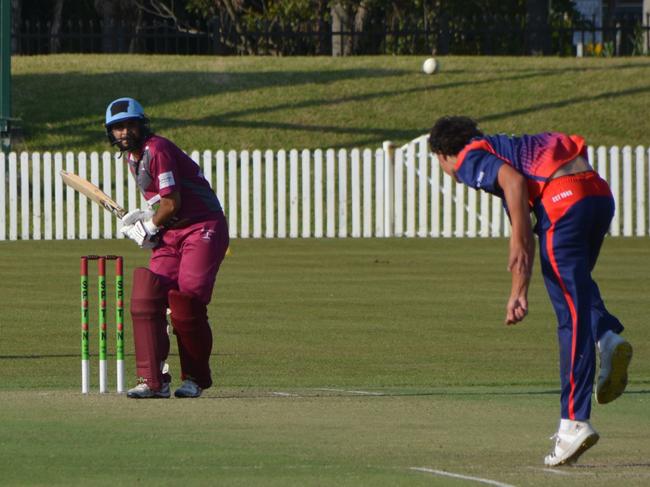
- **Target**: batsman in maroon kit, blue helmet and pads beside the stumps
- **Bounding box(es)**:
[105,98,229,399]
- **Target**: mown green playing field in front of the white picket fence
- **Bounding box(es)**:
[0,238,650,486]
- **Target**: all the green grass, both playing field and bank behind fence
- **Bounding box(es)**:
[0,55,650,487]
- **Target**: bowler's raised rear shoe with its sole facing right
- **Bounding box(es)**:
[596,331,632,404]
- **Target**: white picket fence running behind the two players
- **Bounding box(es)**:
[0,136,650,241]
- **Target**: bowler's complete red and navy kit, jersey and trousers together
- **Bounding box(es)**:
[454,132,623,421]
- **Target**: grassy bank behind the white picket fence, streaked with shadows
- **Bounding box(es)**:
[12,55,650,152]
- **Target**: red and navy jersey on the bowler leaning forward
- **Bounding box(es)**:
[454,132,587,207]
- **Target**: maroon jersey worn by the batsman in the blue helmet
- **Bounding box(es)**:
[128,135,221,221]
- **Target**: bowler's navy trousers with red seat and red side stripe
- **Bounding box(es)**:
[534,172,623,421]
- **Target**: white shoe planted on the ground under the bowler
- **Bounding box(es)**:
[544,419,600,467]
